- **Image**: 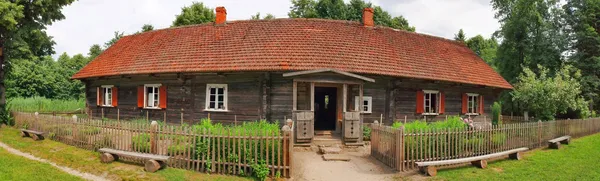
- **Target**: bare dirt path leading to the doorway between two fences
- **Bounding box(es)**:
[292,147,396,181]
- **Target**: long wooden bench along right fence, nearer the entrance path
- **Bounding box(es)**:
[416,147,529,176]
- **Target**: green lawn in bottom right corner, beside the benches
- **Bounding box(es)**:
[431,134,600,180]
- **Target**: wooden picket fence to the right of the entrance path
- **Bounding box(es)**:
[371,118,600,171]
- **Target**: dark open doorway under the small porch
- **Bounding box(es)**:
[315,87,337,130]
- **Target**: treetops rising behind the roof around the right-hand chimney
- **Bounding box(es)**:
[288,0,415,31]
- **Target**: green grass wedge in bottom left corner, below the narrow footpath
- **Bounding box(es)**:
[0,148,83,181]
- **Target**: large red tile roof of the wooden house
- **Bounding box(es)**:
[72,19,512,89]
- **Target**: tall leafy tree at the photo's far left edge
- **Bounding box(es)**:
[0,0,73,115]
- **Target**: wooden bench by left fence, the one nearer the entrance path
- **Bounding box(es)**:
[98,148,169,172]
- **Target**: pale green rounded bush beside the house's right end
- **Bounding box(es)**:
[512,66,589,120]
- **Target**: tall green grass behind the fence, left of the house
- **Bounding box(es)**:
[9,97,85,112]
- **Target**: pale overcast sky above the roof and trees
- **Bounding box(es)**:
[48,0,499,58]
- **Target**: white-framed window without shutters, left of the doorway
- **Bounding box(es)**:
[206,84,227,111]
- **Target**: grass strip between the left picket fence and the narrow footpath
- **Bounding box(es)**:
[0,127,251,181]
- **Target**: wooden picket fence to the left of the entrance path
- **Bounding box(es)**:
[12,112,293,178]
